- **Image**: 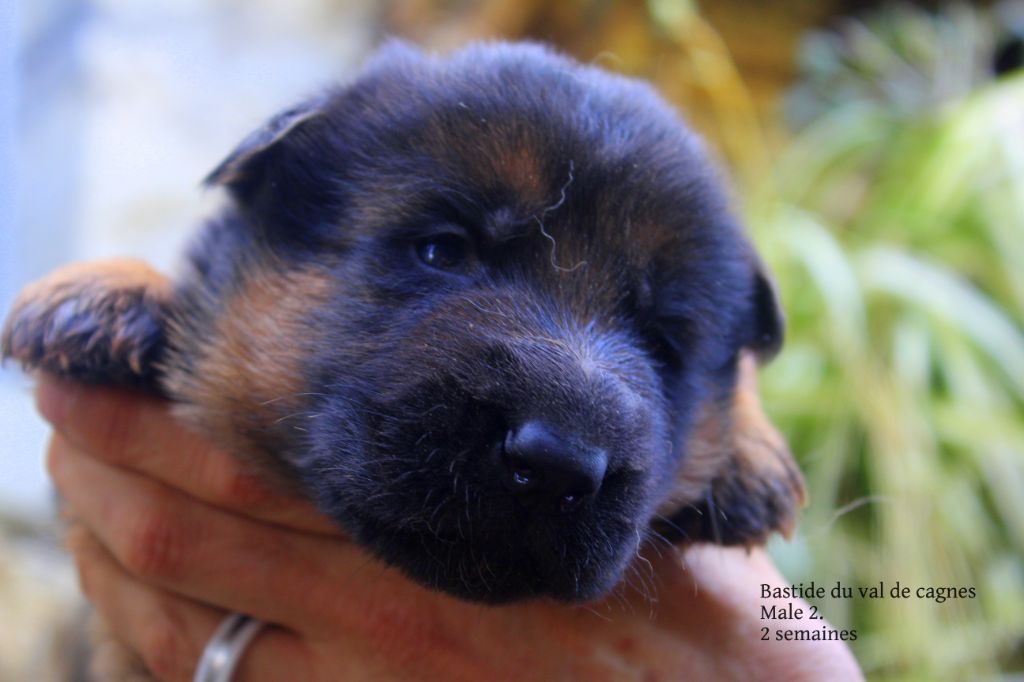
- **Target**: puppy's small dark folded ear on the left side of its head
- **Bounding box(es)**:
[204,97,326,205]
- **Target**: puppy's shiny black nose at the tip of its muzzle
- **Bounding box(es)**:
[504,420,608,512]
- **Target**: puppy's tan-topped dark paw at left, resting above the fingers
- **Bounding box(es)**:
[2,260,171,386]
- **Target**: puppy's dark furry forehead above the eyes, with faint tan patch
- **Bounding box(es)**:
[330,45,715,241]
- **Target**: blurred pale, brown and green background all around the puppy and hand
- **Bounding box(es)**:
[0,0,1024,682]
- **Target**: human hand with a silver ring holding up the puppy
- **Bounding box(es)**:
[37,377,862,682]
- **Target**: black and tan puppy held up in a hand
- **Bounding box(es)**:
[3,43,804,667]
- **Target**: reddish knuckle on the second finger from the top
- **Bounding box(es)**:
[119,505,187,581]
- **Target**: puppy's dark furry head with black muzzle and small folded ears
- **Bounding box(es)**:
[188,45,781,602]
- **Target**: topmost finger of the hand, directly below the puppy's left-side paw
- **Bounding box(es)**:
[36,375,339,535]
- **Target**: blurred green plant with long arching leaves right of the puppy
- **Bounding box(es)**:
[652,3,1024,681]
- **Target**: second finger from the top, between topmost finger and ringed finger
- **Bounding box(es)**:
[48,435,385,634]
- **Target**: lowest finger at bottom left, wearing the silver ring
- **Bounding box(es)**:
[68,527,313,682]
